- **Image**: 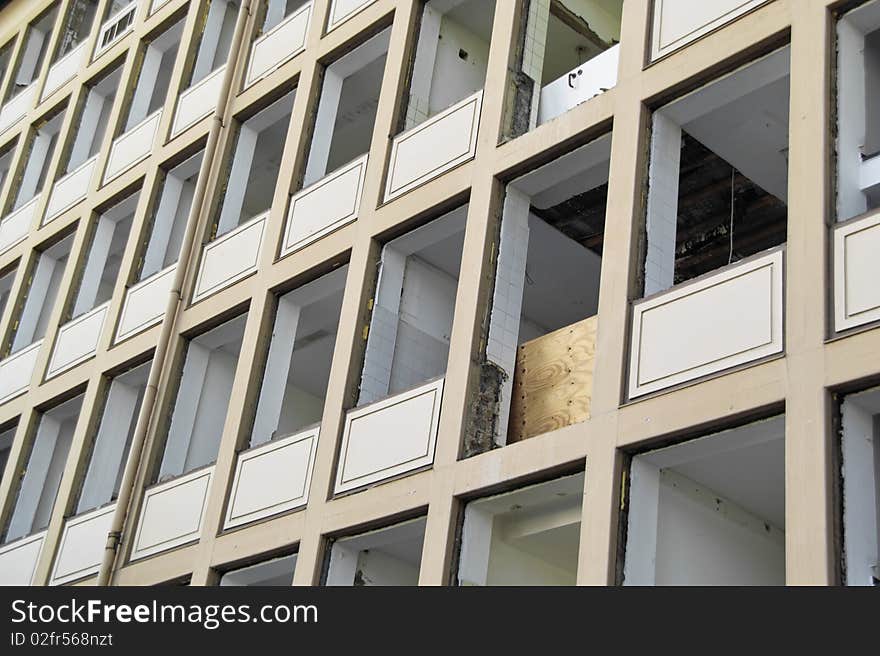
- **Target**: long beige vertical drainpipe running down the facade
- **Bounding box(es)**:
[97,0,253,585]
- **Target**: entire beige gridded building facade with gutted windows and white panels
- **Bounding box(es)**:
[0,0,880,585]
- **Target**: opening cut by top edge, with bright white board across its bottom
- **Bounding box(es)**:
[508,0,623,136]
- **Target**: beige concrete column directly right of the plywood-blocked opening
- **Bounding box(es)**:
[577,2,650,585]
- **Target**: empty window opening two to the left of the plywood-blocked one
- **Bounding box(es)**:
[250,266,348,446]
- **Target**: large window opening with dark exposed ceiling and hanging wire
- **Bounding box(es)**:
[644,47,789,296]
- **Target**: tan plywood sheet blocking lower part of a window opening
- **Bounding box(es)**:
[507,316,598,442]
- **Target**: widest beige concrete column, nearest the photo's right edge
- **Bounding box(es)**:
[785,0,838,585]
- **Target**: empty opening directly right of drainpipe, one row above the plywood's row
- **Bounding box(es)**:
[216,91,296,236]
